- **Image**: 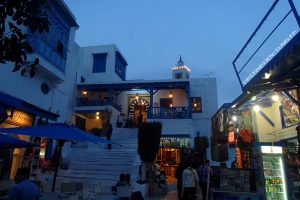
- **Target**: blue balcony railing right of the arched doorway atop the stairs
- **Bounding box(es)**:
[148,107,191,119]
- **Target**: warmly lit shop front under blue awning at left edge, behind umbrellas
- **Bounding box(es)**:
[0,92,58,180]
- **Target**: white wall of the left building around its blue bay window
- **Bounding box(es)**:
[0,5,79,122]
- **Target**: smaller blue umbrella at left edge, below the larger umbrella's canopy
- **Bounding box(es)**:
[0,134,38,149]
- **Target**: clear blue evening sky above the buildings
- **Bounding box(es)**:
[65,0,298,106]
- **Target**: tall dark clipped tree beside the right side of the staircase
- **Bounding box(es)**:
[138,122,162,195]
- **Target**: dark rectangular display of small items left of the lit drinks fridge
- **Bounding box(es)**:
[220,169,250,192]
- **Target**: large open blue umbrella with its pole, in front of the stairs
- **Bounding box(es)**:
[0,124,119,192]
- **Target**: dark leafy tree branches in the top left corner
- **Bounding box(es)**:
[0,0,50,78]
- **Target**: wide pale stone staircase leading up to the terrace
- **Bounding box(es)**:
[56,128,140,193]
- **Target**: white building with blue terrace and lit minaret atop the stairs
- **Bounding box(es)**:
[75,45,218,158]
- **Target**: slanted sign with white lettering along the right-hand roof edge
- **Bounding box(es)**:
[243,31,298,85]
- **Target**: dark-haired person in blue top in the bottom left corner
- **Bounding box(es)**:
[8,168,40,200]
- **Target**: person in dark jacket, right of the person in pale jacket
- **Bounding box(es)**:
[199,160,212,200]
